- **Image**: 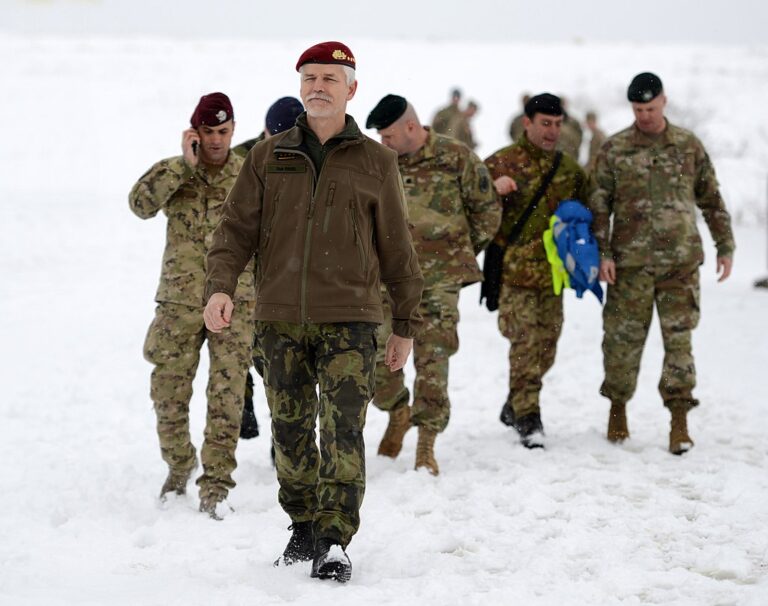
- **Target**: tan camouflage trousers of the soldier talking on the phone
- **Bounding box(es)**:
[144,302,255,498]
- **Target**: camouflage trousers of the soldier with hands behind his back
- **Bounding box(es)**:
[373,285,460,433]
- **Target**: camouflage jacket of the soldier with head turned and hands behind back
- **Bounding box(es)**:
[398,130,501,289]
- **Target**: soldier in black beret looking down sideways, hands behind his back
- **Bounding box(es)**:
[366,95,501,475]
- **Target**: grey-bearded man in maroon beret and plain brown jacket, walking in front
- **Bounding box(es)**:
[204,42,423,582]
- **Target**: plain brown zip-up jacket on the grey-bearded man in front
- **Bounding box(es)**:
[205,116,423,337]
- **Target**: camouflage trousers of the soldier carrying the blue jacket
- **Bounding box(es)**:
[499,282,563,418]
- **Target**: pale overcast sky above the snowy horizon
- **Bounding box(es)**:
[0,0,768,44]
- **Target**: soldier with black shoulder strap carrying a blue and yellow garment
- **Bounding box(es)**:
[485,93,587,448]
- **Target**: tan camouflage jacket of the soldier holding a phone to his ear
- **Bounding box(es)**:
[128,153,255,307]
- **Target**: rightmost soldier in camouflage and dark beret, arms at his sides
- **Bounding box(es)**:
[590,72,735,454]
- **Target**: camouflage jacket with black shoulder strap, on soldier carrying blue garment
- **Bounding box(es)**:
[485,133,587,288]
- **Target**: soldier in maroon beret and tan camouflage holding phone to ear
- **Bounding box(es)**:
[129,93,255,518]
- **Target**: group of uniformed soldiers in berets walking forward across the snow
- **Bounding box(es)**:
[129,42,734,582]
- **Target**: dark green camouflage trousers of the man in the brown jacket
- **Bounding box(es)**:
[256,322,376,546]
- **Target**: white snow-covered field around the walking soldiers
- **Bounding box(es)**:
[0,36,768,606]
